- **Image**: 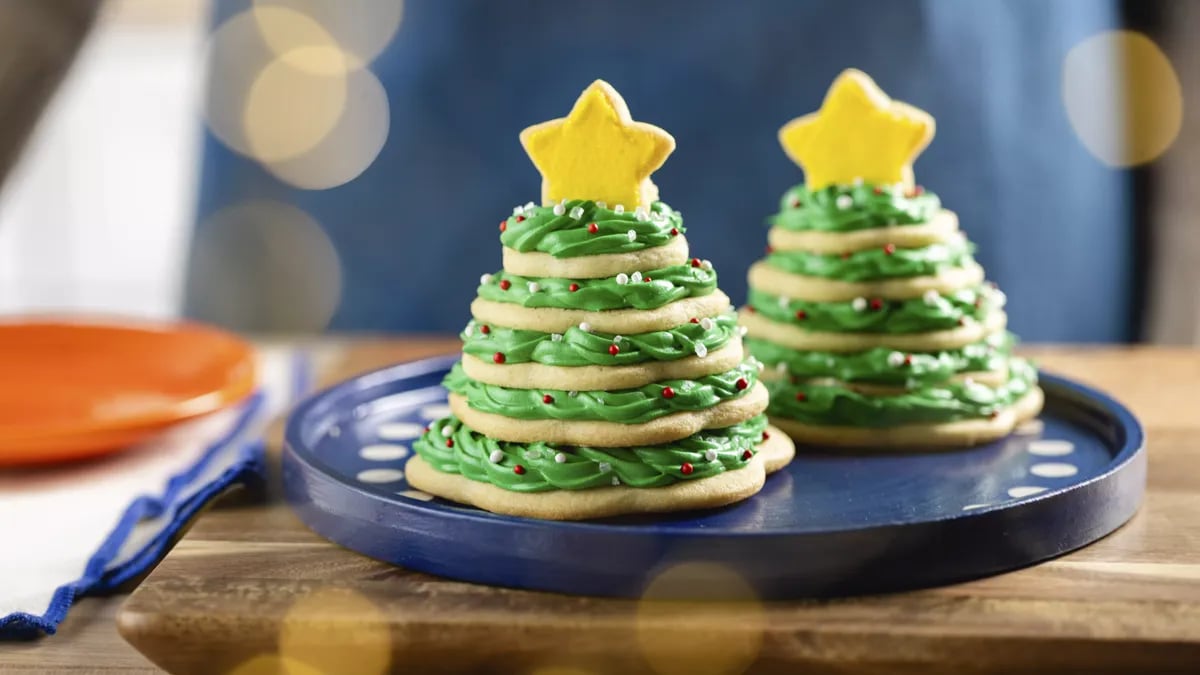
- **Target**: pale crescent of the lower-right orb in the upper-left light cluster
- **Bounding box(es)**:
[265,70,391,190]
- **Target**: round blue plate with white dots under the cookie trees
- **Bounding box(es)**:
[283,357,1146,599]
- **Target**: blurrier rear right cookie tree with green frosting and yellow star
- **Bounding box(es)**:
[740,70,1042,448]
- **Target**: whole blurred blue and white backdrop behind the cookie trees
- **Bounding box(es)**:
[0,0,1200,344]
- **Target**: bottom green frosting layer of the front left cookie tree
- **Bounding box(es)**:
[413,416,767,492]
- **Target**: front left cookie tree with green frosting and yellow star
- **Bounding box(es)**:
[407,82,793,519]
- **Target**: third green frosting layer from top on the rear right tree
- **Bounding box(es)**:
[749,286,1002,334]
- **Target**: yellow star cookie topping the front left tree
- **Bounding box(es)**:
[521,79,674,209]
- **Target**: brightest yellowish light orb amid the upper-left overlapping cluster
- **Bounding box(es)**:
[242,46,347,163]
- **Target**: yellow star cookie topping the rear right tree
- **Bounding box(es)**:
[779,68,935,190]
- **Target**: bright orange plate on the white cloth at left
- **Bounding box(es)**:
[0,321,256,466]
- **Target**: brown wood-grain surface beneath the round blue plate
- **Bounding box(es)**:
[7,340,1200,675]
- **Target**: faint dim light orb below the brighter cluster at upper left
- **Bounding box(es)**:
[190,199,342,333]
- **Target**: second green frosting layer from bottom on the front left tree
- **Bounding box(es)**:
[443,360,758,424]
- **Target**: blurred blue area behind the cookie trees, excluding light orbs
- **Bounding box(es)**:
[188,0,1139,341]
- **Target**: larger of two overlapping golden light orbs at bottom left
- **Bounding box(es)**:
[280,589,391,675]
